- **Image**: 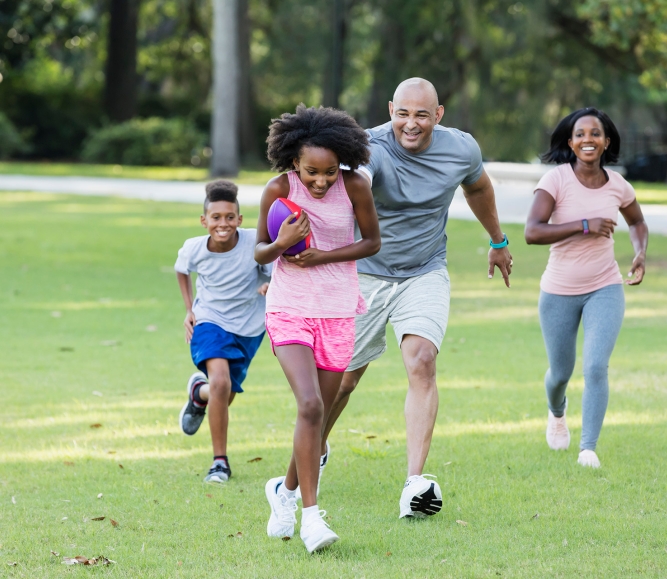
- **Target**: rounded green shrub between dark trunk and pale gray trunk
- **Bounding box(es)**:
[81,117,206,167]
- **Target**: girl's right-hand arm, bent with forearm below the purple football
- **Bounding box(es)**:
[285,171,382,267]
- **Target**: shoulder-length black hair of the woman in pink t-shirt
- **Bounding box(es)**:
[542,107,621,167]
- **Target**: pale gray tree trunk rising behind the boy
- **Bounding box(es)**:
[211,0,239,177]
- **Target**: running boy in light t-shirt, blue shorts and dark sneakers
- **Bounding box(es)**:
[174,179,270,484]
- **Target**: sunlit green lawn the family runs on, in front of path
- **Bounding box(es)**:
[0,193,667,579]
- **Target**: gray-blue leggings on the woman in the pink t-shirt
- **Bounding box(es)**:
[539,284,625,450]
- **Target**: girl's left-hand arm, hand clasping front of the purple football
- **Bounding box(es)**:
[255,175,310,265]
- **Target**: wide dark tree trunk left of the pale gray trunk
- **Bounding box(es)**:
[105,0,139,122]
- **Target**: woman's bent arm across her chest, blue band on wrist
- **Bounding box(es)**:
[524,189,616,245]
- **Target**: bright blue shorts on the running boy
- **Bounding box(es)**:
[190,322,264,392]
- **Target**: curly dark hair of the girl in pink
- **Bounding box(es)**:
[266,103,370,171]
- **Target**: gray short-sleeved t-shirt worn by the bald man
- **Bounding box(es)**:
[357,122,484,281]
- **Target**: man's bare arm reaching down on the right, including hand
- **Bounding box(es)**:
[461,171,512,287]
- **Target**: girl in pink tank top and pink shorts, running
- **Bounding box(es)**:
[255,105,380,553]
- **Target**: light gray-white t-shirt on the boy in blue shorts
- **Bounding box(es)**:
[174,229,271,337]
